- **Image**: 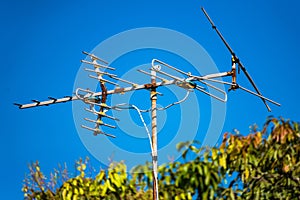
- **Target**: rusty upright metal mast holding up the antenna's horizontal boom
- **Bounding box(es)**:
[150,70,158,200]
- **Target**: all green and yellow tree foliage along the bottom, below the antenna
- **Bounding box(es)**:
[22,118,300,200]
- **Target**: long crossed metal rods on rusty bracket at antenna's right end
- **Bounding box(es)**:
[201,7,280,112]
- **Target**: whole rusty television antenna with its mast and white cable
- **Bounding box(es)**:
[14,8,280,200]
